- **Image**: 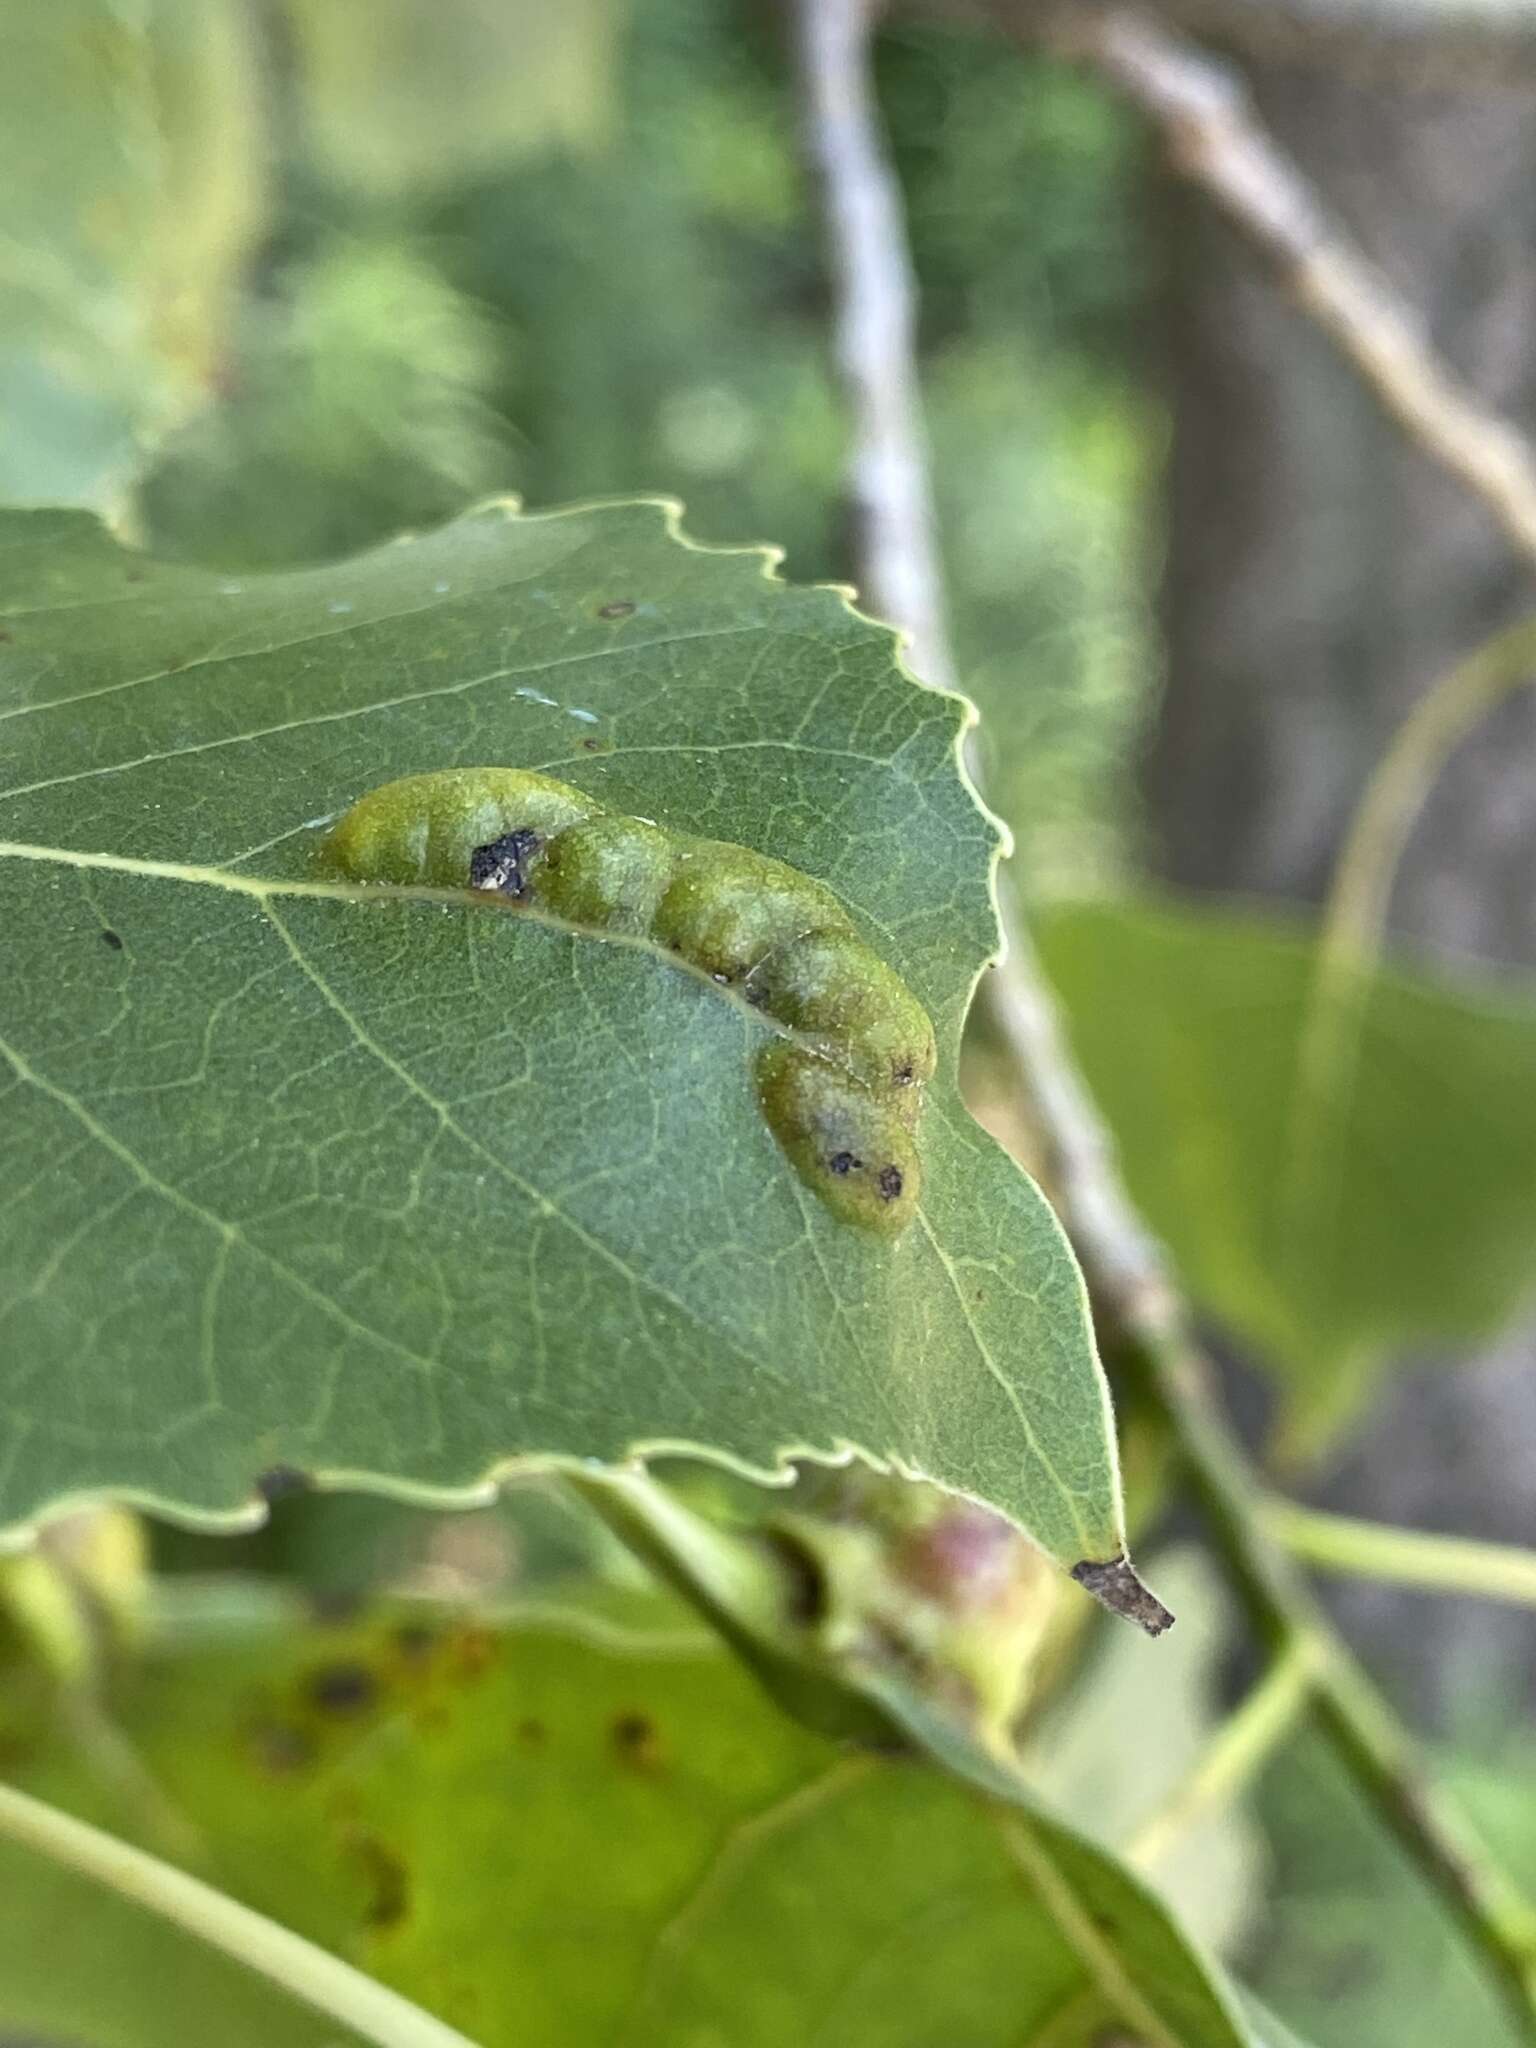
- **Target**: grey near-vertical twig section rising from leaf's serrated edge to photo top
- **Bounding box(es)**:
[795,0,954,690]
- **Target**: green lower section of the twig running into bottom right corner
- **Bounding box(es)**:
[1126,1315,1536,2048]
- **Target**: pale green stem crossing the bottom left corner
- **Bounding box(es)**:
[0,1786,473,2048]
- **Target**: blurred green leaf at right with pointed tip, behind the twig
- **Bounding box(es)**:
[1038,903,1536,1415]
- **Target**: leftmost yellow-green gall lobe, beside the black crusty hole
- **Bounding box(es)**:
[319,768,602,895]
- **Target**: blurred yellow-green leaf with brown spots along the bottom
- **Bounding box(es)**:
[0,1606,1310,2048]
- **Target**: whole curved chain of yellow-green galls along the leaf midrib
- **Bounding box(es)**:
[322,768,936,1237]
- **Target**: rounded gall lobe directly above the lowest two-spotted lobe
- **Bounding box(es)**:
[743,932,938,1116]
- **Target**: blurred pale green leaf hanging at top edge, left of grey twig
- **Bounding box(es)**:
[283,0,627,195]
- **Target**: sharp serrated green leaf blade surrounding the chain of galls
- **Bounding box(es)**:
[0,504,1122,1565]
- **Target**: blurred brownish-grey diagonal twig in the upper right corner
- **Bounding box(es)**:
[1051,6,1536,561]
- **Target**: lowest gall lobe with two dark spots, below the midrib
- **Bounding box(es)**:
[758,1044,922,1237]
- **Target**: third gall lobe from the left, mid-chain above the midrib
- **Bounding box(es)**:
[651,840,850,981]
